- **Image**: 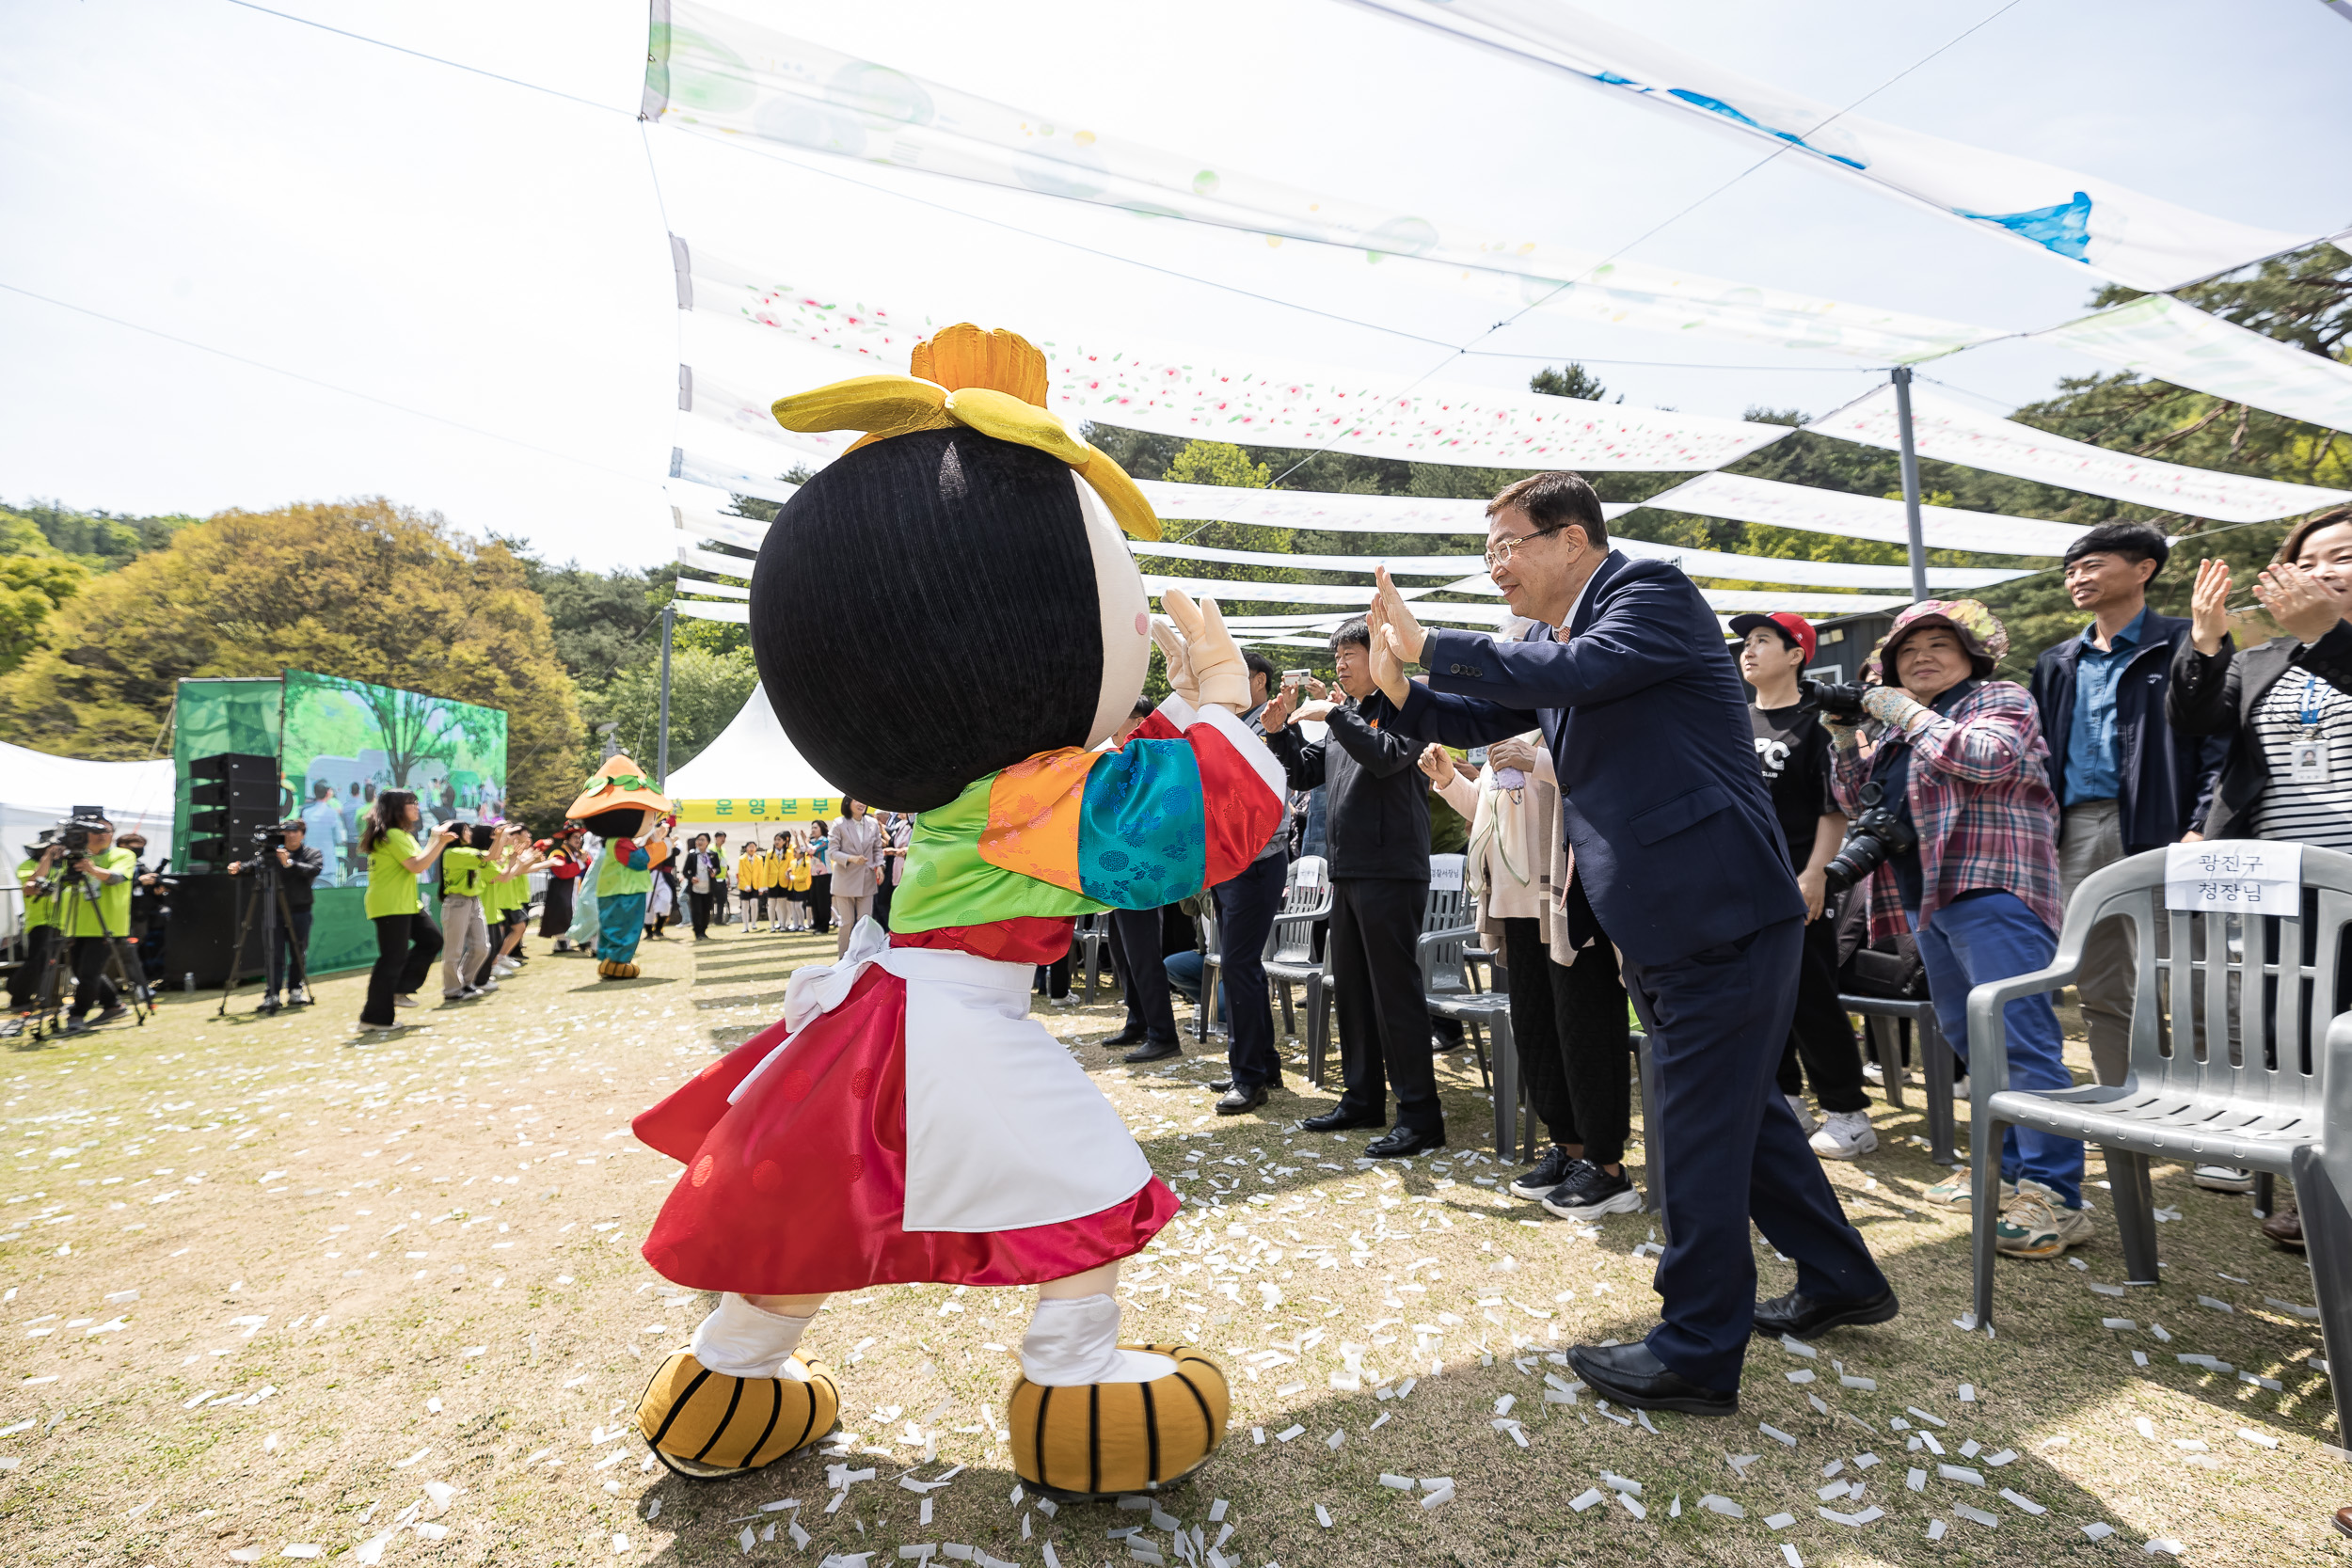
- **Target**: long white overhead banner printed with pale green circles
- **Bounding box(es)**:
[644,0,2004,362]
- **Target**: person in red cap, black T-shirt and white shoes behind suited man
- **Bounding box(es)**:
[1731,609,1880,1159]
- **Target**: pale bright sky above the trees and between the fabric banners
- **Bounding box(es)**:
[0,0,2352,564]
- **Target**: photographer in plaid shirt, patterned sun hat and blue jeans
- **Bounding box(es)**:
[1820,599,2091,1258]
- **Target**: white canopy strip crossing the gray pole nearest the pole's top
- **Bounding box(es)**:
[1806,386,2352,524]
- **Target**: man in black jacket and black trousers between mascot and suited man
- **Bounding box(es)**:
[1259,618,1447,1159]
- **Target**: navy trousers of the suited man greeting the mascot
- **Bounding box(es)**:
[1626,919,1886,1389]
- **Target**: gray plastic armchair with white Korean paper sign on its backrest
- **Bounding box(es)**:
[1969,847,2352,1430]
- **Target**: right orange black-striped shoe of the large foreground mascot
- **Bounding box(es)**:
[1007,1345,1231,1500]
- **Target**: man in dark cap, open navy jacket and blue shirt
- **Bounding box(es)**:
[2032,522,2220,1090]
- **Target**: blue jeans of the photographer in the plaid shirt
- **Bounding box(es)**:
[1913,891,2082,1209]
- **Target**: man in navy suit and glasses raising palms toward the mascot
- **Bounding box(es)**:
[1369,472,1896,1416]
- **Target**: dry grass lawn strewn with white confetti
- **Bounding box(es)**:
[0,927,2352,1568]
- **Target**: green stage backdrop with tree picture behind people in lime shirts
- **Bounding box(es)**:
[278,670,506,974]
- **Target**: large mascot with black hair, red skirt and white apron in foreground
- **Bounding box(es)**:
[635,325,1284,1493]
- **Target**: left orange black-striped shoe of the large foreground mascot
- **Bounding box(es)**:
[638,1350,842,1481]
